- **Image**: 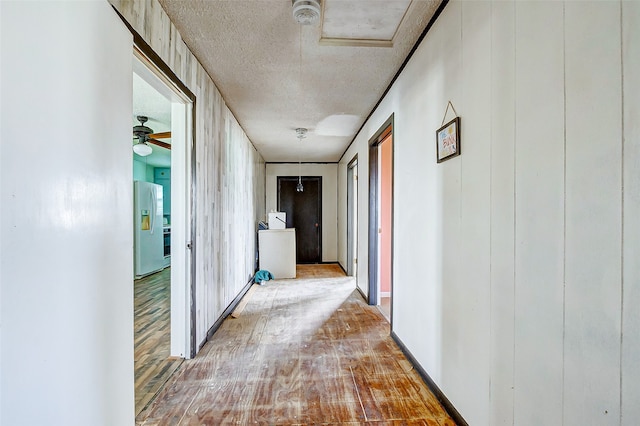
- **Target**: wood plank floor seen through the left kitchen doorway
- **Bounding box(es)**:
[134,268,183,415]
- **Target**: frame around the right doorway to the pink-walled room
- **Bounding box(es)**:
[367,114,395,310]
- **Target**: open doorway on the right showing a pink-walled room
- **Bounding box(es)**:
[369,116,393,321]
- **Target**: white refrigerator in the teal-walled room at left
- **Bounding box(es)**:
[133,181,165,277]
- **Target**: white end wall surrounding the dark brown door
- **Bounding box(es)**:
[263,163,338,262]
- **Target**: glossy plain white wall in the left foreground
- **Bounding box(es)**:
[0,2,134,426]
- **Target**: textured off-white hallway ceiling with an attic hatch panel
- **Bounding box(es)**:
[159,0,440,162]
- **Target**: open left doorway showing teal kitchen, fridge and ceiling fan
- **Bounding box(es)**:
[132,47,195,415]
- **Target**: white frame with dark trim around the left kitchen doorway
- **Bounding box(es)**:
[131,35,197,358]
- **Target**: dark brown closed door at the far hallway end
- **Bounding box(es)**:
[278,176,322,263]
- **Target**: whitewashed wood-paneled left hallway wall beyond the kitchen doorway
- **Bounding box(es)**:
[109,0,265,350]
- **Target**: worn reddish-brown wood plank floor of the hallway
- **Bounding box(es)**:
[138,265,454,426]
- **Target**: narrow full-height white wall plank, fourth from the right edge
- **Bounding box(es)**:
[489,1,516,426]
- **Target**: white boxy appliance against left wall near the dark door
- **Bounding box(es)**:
[258,228,296,279]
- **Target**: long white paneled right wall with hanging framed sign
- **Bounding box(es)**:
[338,1,640,425]
